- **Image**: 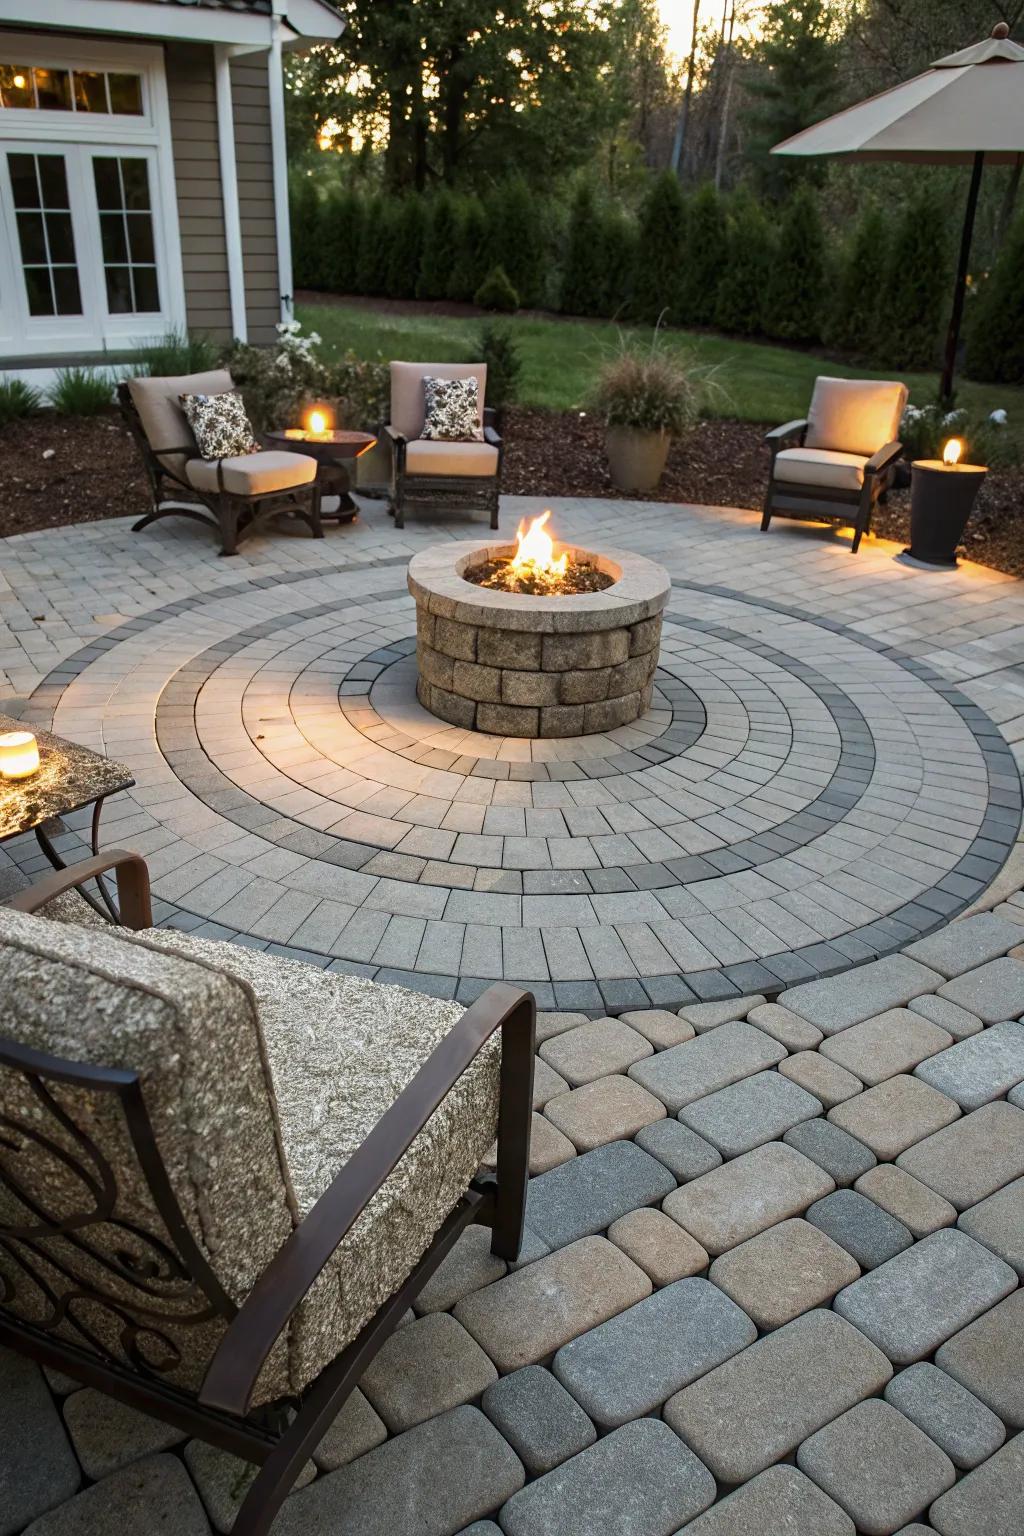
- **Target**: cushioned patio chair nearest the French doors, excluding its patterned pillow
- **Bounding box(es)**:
[117,369,324,554]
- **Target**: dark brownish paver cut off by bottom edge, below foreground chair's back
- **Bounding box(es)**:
[25,1453,208,1536]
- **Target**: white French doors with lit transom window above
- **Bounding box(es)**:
[0,34,184,358]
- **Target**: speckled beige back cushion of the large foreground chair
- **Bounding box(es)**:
[0,908,295,1387]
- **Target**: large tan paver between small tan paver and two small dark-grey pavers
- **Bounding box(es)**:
[662,1141,835,1253]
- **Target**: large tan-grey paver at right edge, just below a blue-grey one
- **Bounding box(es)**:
[897,1103,1024,1210]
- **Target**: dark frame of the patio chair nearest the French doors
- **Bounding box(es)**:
[117,384,324,554]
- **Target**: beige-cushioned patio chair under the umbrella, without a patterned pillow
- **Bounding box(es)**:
[761,378,907,554]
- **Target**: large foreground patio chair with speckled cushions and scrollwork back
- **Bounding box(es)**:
[0,851,534,1536]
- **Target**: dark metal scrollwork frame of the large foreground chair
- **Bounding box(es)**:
[0,849,536,1536]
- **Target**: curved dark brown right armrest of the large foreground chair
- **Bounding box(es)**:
[200,982,536,1416]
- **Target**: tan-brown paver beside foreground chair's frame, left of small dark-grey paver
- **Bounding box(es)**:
[359,1312,497,1435]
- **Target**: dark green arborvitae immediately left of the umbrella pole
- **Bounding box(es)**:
[877,192,950,369]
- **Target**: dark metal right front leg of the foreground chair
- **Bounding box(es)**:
[491,992,537,1260]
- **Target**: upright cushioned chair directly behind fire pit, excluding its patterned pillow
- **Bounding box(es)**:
[384,362,502,528]
